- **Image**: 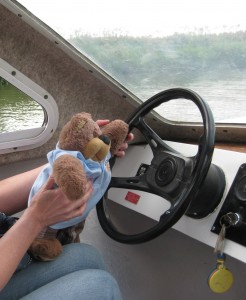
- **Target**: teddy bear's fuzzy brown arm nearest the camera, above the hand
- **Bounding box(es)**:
[53,154,87,200]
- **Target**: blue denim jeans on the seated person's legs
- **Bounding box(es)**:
[0,244,122,300]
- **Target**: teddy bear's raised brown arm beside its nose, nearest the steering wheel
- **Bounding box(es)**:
[102,120,129,155]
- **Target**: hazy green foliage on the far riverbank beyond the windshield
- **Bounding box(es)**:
[70,31,246,88]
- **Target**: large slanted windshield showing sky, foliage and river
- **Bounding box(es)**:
[20,0,246,123]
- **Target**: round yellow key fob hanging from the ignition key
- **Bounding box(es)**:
[208,265,234,293]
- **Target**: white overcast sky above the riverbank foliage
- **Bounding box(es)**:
[19,0,246,37]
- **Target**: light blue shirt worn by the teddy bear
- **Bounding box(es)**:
[28,146,111,229]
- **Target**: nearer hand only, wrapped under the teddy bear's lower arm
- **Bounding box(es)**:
[27,176,93,227]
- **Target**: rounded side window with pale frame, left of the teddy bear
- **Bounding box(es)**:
[0,59,58,153]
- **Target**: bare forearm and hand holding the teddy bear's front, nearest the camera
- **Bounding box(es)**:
[0,177,92,291]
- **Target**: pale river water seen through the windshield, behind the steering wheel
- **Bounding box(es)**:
[138,80,246,123]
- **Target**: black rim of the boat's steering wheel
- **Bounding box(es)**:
[97,88,215,244]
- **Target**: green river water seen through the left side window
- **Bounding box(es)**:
[0,82,44,132]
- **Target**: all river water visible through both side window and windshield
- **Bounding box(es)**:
[0,80,246,132]
